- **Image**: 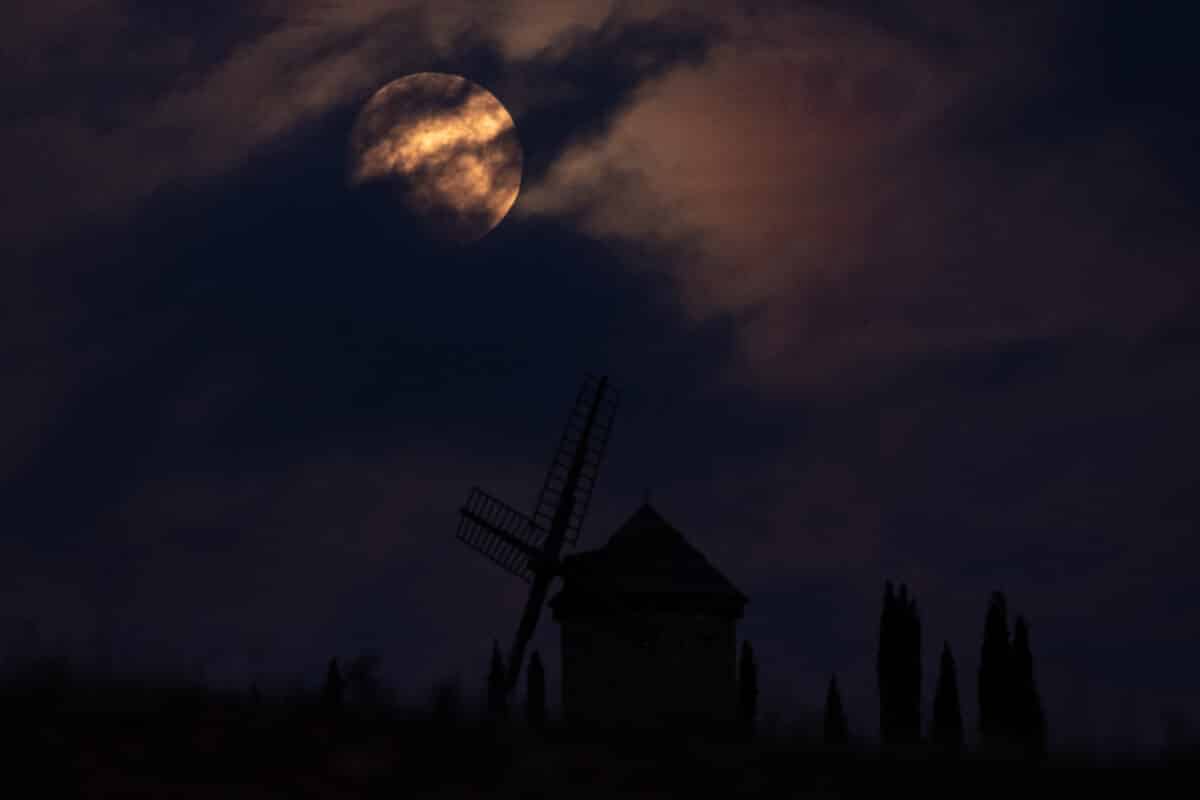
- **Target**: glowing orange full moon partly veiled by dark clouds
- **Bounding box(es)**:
[348,72,522,243]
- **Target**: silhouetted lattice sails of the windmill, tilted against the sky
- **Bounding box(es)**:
[457,374,618,693]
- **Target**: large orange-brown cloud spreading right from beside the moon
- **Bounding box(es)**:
[521,4,1186,391]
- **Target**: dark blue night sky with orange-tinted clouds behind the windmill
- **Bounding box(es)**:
[9,0,1200,746]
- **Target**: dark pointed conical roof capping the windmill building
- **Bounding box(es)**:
[550,504,746,614]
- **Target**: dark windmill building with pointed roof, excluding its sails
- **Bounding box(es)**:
[550,504,746,726]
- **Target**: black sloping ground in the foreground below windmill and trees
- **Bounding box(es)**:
[4,671,1198,800]
